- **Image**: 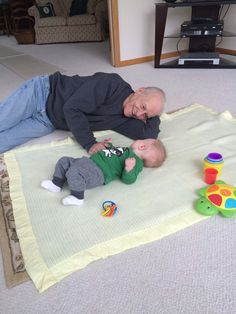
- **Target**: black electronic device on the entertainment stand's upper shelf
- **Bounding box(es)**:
[180,18,224,37]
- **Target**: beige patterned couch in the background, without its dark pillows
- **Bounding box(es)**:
[28,0,108,44]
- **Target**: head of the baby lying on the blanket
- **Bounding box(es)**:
[131,138,166,168]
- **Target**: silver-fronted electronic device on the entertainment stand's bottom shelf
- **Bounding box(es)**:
[178,52,220,65]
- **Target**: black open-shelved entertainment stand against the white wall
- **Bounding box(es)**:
[154,0,236,69]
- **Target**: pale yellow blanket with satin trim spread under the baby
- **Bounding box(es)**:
[5,104,236,292]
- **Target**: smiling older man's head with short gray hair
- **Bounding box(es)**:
[123,87,165,121]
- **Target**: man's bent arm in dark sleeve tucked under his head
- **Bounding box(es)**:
[113,117,160,140]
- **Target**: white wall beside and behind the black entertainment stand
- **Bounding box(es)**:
[118,0,236,61]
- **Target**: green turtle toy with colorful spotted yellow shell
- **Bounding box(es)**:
[195,180,236,217]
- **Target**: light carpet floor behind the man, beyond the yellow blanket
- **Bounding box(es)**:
[0,36,236,114]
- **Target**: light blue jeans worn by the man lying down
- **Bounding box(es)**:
[0,76,55,153]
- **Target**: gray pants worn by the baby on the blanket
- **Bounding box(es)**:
[52,157,104,199]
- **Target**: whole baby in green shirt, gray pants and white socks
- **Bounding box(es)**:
[41,139,166,205]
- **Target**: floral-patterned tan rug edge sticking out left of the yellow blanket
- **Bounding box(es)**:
[0,155,29,288]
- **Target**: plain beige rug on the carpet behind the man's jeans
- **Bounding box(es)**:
[0,54,64,80]
